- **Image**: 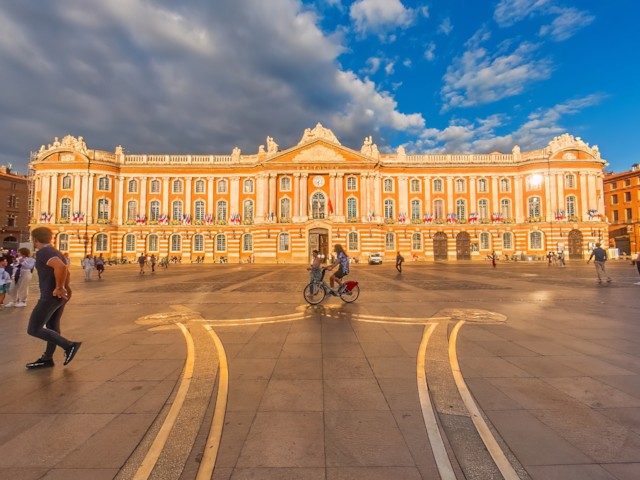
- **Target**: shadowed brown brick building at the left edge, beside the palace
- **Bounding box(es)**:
[0,166,29,250]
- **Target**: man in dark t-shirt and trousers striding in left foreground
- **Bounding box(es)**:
[26,227,82,369]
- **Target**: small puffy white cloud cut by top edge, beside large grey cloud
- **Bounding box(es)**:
[350,0,415,35]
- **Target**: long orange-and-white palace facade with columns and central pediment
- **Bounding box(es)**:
[30,124,608,263]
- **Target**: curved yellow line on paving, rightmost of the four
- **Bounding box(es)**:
[449,320,520,480]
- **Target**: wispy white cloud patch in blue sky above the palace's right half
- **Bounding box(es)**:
[441,30,552,110]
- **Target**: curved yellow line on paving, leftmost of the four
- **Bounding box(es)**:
[133,323,195,480]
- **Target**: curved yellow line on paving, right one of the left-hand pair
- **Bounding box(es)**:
[196,327,229,480]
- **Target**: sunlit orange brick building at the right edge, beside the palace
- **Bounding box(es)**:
[604,164,640,255]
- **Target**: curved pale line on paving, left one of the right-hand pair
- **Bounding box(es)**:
[417,323,456,480]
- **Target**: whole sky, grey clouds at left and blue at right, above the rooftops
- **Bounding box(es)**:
[0,0,640,172]
